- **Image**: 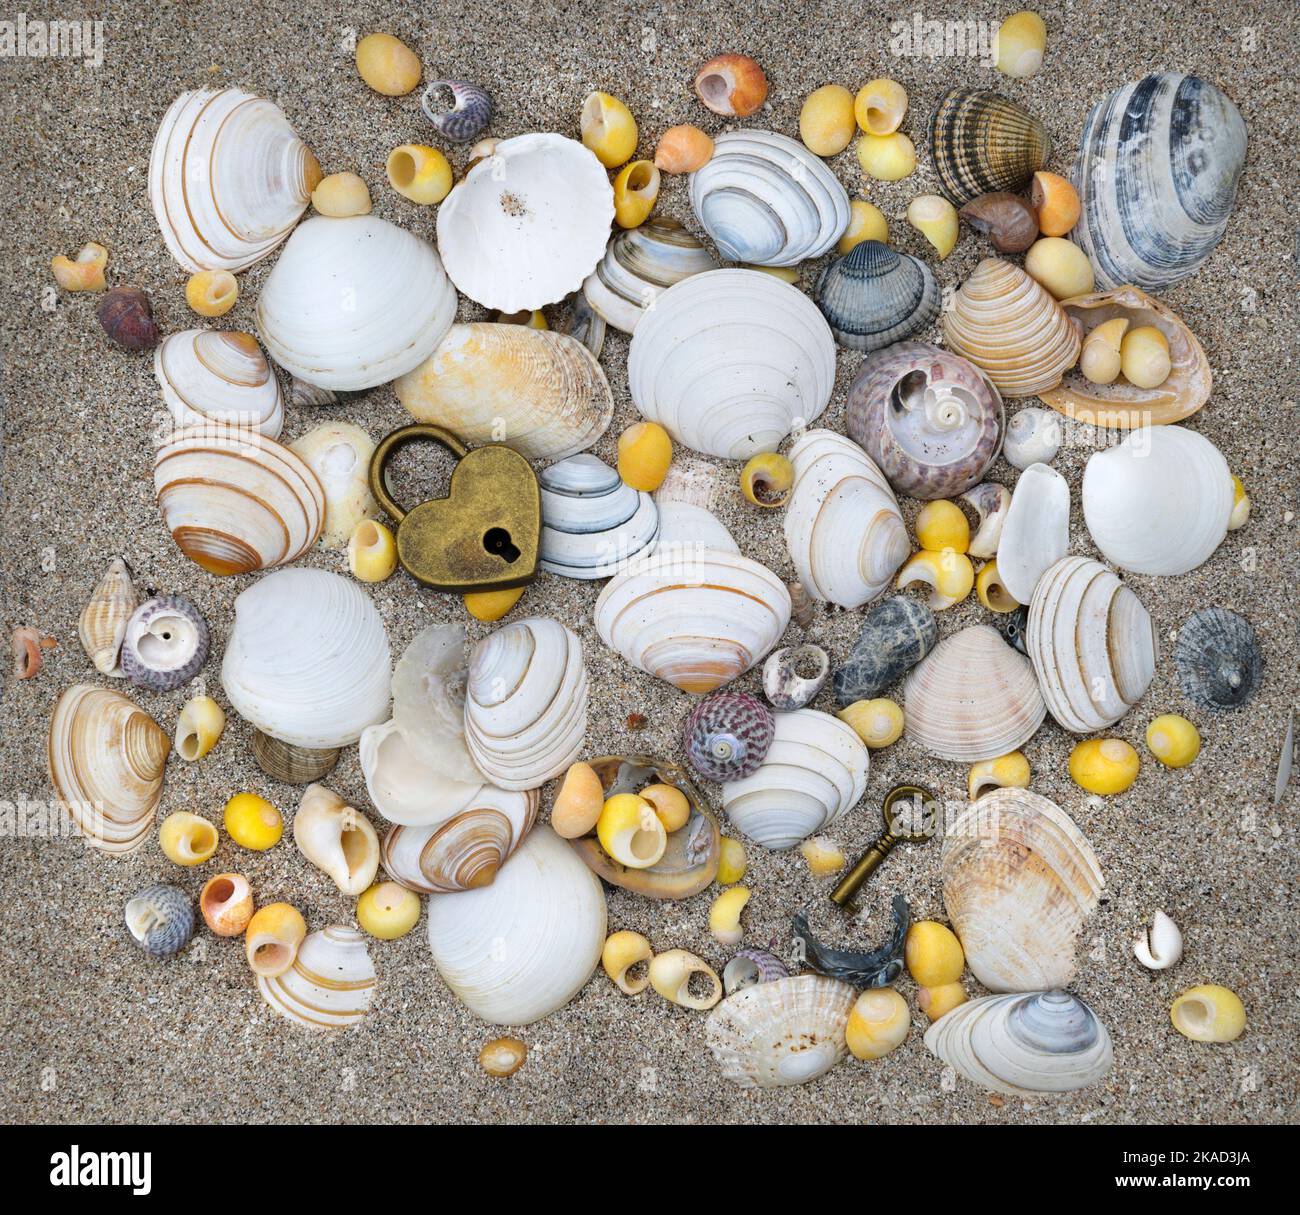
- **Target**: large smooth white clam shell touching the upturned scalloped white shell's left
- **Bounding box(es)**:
[255,216,456,390]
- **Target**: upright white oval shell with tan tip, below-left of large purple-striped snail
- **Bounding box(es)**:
[784,430,911,608]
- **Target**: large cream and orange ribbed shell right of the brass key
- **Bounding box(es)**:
[940,789,1105,991]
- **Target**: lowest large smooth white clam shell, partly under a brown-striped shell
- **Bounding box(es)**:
[429,825,606,1025]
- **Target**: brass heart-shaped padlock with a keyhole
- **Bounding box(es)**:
[371,422,542,595]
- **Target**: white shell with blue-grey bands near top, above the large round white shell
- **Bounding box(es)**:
[690,130,849,266]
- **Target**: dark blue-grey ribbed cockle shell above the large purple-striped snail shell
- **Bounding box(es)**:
[814,240,943,351]
